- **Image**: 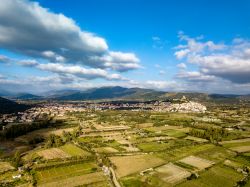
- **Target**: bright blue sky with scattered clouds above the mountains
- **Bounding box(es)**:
[0,0,250,94]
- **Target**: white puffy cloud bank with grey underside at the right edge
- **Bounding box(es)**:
[175,34,250,84]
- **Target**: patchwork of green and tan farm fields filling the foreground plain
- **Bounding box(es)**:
[0,106,250,187]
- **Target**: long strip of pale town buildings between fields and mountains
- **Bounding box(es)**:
[0,101,206,123]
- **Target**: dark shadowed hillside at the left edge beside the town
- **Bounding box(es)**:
[0,97,29,114]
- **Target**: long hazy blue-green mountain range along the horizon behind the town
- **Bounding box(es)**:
[0,86,250,101]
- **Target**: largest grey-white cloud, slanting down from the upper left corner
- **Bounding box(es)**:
[0,0,139,71]
